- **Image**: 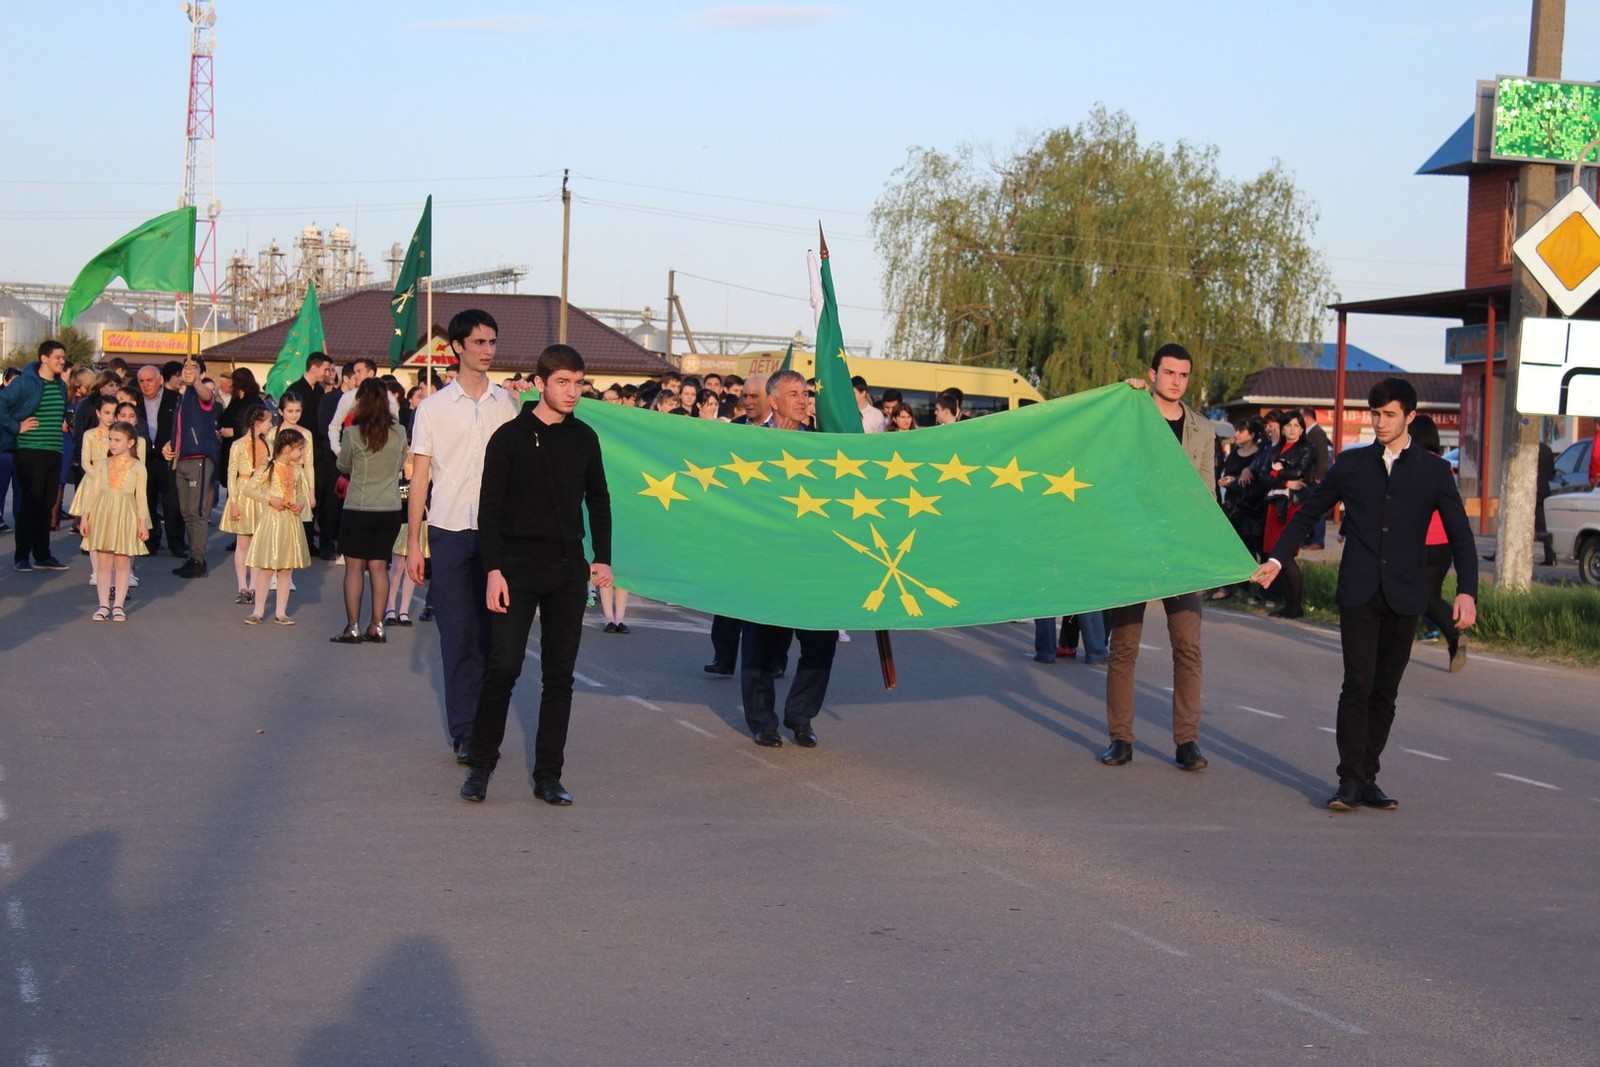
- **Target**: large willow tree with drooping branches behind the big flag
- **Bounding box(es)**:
[872,109,1333,400]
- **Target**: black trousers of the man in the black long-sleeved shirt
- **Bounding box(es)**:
[467,553,589,782]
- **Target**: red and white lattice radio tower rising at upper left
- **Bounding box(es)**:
[178,0,222,333]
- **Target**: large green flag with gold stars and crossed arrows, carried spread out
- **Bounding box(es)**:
[578,384,1254,630]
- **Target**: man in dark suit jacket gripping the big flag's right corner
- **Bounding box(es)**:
[1251,378,1478,811]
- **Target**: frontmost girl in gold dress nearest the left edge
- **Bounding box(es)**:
[74,422,150,622]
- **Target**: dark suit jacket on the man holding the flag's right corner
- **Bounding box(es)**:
[1270,442,1478,614]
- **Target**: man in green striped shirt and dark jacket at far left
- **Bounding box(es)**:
[0,341,72,571]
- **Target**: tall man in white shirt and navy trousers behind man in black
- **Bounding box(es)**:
[406,309,517,763]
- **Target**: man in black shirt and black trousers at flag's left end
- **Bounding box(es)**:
[461,344,611,805]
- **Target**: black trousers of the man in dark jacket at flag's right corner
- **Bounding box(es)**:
[1334,589,1418,785]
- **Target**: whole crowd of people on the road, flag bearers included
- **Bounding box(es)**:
[0,329,1477,811]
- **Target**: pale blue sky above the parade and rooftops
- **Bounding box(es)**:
[0,0,1600,371]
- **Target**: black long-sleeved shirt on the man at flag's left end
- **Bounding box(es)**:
[478,400,611,571]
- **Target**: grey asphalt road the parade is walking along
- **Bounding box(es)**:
[0,545,1600,1067]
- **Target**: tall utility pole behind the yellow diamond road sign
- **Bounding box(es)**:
[1485,0,1566,589]
